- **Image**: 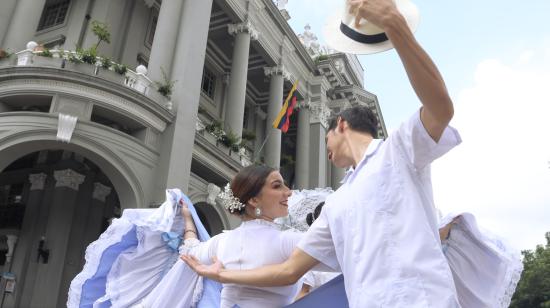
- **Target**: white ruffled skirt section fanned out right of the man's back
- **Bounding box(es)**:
[439,213,523,308]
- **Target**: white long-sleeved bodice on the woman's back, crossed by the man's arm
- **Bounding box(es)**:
[181,219,302,308]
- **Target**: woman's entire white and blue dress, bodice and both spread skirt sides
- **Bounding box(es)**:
[67,190,522,308]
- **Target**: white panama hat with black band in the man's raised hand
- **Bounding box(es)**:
[324,0,420,54]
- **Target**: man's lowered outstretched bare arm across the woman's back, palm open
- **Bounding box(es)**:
[181,248,319,287]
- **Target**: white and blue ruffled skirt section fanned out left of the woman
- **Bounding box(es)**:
[67,189,221,308]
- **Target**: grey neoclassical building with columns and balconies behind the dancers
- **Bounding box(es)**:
[0,0,386,307]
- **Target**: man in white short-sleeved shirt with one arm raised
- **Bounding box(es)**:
[182,0,460,308]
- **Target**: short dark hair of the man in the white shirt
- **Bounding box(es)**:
[328,106,378,138]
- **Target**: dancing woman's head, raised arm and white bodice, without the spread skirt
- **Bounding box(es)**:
[156,166,328,308]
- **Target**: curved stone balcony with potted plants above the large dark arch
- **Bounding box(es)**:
[0,42,175,151]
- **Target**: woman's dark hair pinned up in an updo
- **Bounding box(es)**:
[231,165,275,215]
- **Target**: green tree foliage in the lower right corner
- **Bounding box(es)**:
[510,232,550,308]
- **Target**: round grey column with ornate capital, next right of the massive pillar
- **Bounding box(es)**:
[224,22,258,138]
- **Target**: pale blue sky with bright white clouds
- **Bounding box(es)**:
[286,0,550,249]
